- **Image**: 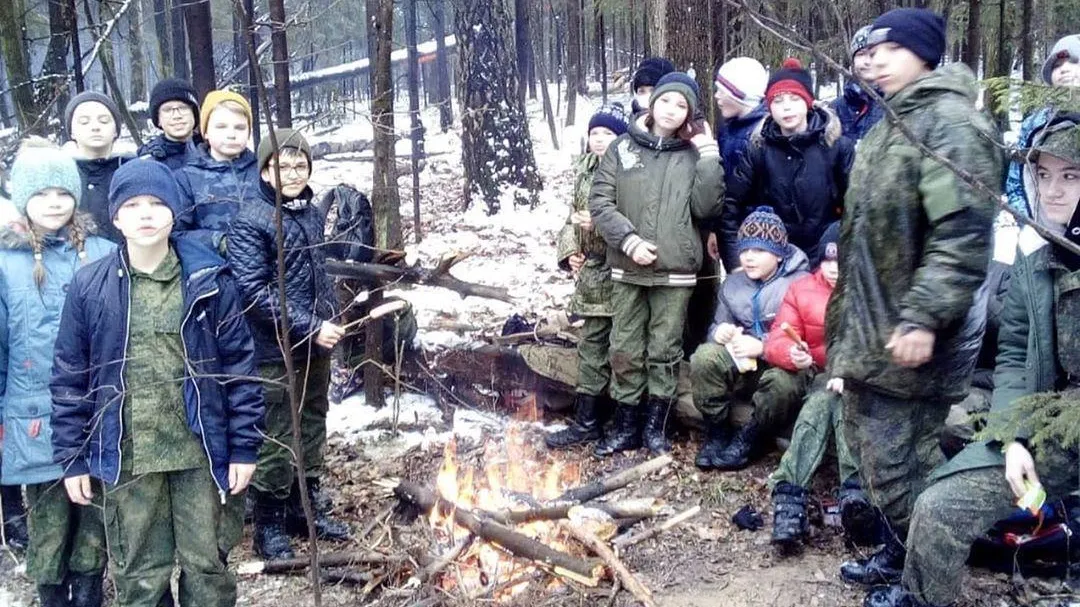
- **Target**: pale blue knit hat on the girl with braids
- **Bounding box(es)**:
[8,137,82,215]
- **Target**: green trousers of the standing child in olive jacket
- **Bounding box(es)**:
[610,282,693,406]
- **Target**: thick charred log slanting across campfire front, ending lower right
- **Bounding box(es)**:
[394,481,603,586]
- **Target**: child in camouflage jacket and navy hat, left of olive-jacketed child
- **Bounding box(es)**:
[545,105,626,449]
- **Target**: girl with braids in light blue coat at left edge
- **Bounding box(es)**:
[0,138,114,606]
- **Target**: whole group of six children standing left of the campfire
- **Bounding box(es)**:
[0,80,349,607]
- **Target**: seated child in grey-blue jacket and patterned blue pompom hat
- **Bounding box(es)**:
[690,206,810,470]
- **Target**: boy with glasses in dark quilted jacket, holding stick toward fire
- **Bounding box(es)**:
[228,129,349,559]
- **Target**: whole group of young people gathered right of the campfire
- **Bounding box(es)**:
[546,9,1080,607]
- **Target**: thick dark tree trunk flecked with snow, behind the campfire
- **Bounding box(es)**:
[454,0,540,213]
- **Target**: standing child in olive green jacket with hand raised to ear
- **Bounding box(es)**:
[589,72,724,457]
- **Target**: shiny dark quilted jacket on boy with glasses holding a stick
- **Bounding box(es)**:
[227,181,337,364]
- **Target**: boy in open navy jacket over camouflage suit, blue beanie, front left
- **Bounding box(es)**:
[50,159,264,607]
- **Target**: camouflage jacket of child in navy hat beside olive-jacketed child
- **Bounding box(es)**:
[556,152,611,316]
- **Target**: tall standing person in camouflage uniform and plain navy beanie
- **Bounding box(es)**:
[826,9,1001,584]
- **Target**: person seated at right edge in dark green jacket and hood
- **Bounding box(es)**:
[865,114,1080,607]
